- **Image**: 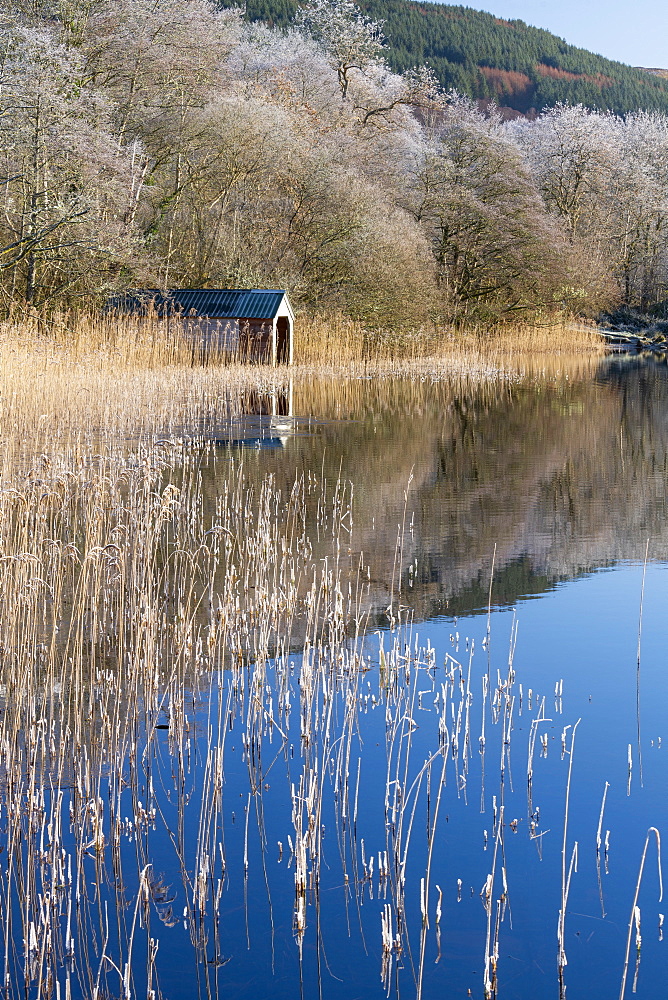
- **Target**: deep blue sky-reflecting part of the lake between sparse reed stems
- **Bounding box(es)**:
[142,564,668,998]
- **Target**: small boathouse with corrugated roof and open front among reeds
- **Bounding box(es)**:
[110,288,295,365]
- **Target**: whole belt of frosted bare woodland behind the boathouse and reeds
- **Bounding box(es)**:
[0,0,668,329]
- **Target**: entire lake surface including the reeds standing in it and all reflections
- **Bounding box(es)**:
[0,359,668,998]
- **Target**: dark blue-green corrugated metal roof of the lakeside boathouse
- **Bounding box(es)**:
[109,288,285,320]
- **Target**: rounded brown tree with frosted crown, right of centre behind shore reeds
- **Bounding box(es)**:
[411,95,570,318]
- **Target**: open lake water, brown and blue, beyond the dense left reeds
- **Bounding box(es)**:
[32,358,668,1000]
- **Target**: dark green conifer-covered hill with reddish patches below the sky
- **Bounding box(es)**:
[222,0,668,114]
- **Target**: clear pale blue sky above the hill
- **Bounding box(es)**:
[449,0,668,69]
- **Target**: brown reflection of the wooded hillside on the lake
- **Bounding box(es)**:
[198,358,668,614]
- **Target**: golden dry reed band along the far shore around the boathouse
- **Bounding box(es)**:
[0,315,601,482]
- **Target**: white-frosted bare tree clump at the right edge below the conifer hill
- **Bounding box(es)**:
[508,106,668,306]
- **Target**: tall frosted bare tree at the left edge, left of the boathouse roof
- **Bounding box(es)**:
[0,24,143,304]
